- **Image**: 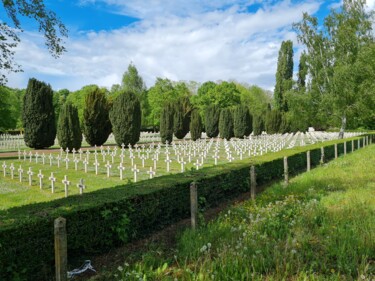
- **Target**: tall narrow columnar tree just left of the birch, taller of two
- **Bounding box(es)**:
[274,40,293,111]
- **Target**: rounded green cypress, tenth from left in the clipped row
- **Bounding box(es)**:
[233,105,253,139]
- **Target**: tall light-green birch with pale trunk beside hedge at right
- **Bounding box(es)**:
[294,0,374,138]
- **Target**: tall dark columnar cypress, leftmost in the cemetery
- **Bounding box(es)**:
[22,78,56,148]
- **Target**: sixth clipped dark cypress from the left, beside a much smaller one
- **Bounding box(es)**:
[173,96,191,139]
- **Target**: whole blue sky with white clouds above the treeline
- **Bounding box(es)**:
[0,0,375,91]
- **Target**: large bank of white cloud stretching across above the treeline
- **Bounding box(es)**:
[9,0,320,90]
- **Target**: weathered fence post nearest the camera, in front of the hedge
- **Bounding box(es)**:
[54,217,68,281]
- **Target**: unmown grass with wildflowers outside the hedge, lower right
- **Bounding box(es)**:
[111,145,375,281]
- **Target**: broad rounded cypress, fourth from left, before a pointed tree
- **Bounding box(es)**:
[109,91,142,146]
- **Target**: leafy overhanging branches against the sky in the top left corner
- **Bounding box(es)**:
[0,0,68,84]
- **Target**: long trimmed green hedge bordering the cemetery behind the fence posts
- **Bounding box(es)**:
[0,136,374,281]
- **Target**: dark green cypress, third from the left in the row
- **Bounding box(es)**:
[83,87,112,146]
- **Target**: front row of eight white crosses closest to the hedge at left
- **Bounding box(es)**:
[2,161,86,197]
